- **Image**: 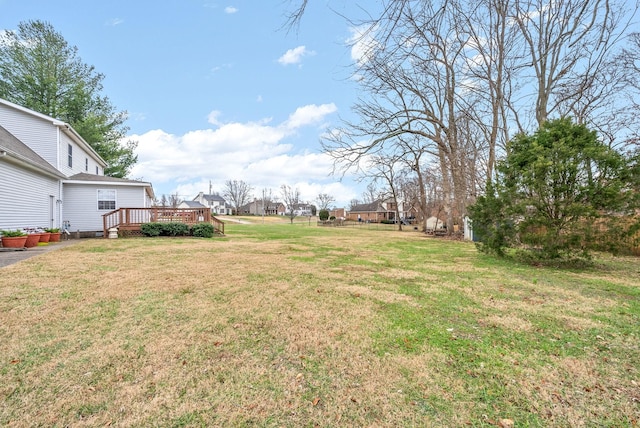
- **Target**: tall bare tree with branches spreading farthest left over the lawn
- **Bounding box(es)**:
[323,2,468,230]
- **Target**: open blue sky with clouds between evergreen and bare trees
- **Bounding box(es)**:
[0,0,376,206]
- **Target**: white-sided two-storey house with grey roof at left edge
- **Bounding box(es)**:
[0,99,154,236]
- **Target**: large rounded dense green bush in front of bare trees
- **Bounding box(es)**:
[469,119,638,259]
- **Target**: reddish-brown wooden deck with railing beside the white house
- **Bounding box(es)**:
[102,207,224,238]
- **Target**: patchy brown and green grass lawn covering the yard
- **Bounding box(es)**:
[0,219,640,427]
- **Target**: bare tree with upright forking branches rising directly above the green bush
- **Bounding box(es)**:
[511,0,628,126]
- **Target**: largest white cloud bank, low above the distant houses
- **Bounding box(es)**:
[127,103,356,204]
